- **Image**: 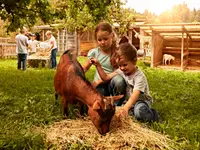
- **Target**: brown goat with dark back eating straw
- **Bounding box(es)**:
[54,50,123,134]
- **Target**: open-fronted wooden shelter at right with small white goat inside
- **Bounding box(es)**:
[140,23,200,70]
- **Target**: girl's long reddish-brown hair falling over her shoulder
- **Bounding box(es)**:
[95,22,118,69]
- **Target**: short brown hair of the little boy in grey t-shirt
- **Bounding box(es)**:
[117,42,137,61]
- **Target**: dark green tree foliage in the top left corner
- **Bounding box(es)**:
[0,0,51,31]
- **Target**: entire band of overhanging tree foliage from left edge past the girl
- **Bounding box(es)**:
[0,0,134,31]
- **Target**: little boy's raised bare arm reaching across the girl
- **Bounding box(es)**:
[90,58,118,81]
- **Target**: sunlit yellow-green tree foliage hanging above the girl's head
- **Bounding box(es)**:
[51,0,136,34]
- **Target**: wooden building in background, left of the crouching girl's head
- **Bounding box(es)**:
[34,24,96,56]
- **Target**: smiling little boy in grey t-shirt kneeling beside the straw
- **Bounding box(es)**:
[90,42,158,121]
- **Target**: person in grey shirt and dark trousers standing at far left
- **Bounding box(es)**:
[15,27,28,70]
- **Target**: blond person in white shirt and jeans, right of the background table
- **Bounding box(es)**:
[46,31,58,69]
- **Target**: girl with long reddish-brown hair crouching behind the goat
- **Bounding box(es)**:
[83,22,126,105]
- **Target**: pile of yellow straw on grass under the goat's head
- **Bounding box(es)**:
[39,109,175,150]
